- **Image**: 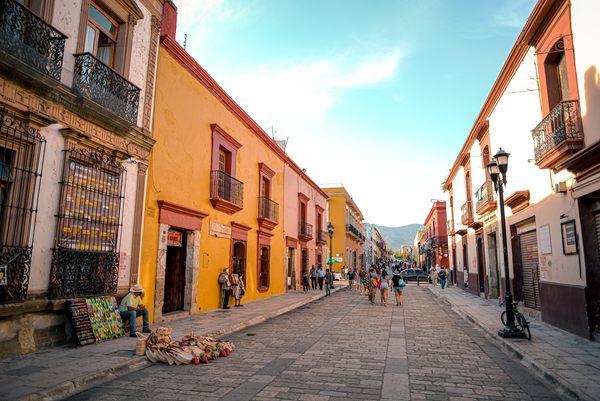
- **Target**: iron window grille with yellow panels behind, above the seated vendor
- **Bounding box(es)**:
[48,149,127,299]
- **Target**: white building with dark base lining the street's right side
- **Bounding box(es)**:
[444,0,600,339]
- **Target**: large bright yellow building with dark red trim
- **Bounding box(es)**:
[139,2,286,322]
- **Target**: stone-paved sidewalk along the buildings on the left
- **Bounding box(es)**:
[0,282,347,401]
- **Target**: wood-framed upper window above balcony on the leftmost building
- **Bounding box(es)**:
[84,2,119,68]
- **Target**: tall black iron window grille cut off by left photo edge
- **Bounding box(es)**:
[0,104,46,304]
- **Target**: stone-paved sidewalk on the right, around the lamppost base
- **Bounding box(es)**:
[429,286,600,400]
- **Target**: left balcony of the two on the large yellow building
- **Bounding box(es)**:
[210,170,244,215]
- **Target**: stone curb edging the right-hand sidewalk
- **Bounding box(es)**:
[429,288,593,401]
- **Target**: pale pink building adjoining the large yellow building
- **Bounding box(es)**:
[284,159,328,291]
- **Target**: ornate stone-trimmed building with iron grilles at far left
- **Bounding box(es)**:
[0,0,162,358]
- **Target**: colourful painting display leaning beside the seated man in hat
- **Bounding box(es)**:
[68,297,125,346]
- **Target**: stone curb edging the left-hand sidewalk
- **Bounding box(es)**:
[17,286,346,401]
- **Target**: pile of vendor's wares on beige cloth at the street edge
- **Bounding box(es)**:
[136,327,235,365]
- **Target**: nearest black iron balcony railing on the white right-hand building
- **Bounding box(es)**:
[533,100,583,163]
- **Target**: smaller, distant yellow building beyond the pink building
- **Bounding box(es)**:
[322,185,366,272]
